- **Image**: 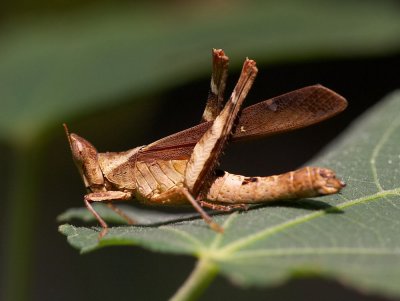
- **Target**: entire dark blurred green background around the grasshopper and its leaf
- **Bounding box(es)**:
[0,0,400,300]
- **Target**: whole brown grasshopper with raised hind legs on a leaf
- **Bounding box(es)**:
[64,49,347,238]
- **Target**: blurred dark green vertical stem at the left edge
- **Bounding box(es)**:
[0,145,40,301]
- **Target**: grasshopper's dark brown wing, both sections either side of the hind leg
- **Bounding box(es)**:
[139,85,347,160]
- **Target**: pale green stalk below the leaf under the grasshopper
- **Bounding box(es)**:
[170,258,218,301]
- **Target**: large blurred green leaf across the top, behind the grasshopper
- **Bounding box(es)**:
[0,0,400,144]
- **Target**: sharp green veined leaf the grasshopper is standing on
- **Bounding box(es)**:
[60,91,400,297]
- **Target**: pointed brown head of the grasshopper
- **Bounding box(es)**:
[64,124,104,191]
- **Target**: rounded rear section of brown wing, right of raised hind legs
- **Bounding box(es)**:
[233,85,347,141]
